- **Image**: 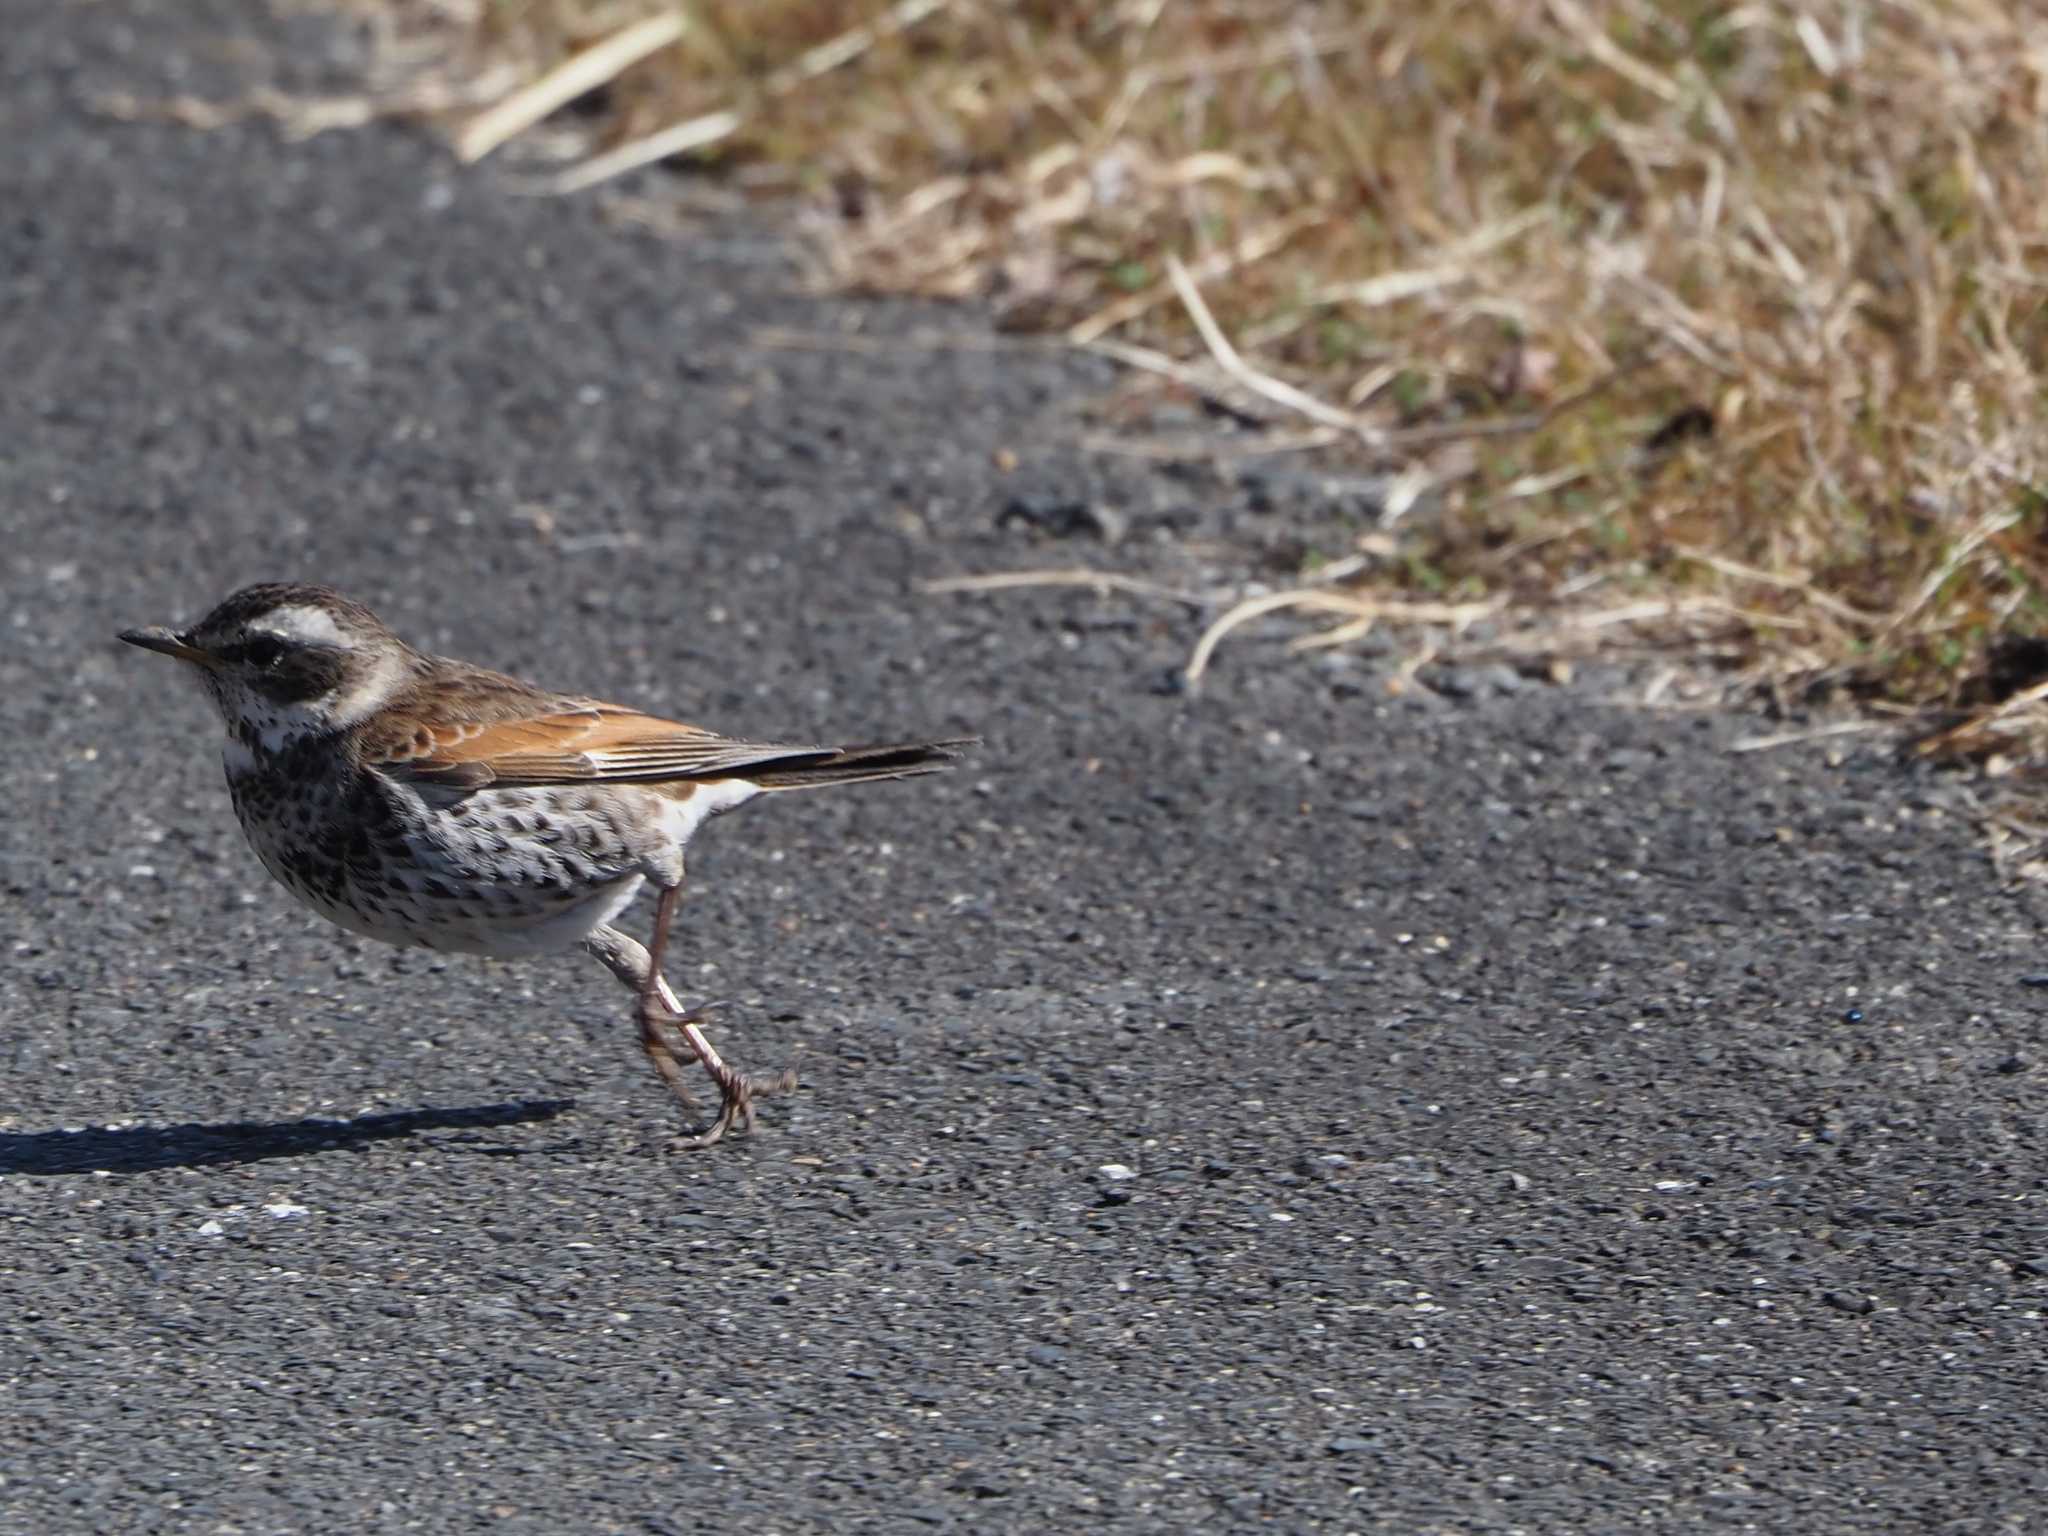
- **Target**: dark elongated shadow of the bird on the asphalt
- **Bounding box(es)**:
[0,1098,575,1178]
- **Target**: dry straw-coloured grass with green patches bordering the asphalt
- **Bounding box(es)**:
[348,0,2048,752]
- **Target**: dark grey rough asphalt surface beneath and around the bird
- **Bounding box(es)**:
[12,0,2048,1534]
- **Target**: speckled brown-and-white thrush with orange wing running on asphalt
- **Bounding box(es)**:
[121,582,977,1147]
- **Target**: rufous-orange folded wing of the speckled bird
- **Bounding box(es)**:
[360,698,831,788]
